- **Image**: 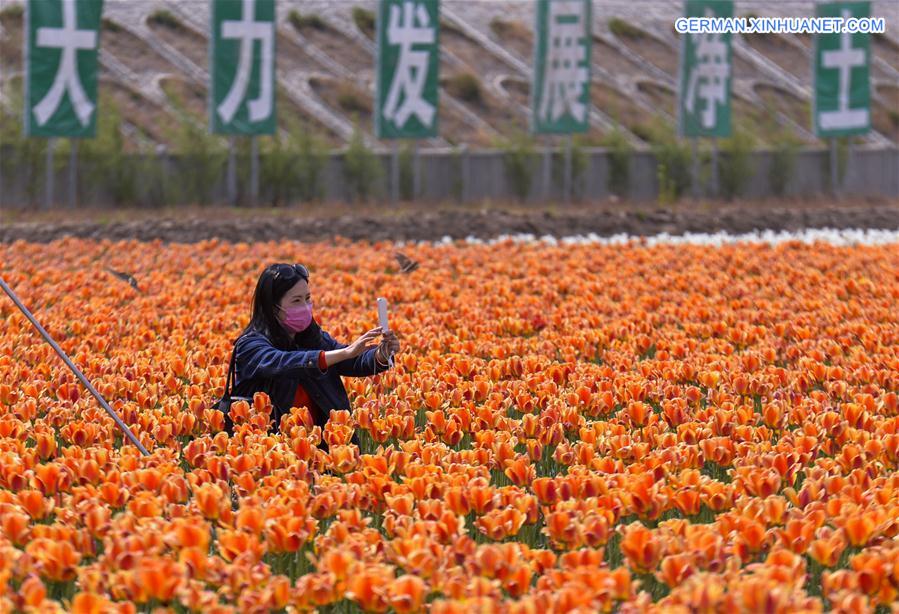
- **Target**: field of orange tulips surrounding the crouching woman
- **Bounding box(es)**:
[0,238,899,614]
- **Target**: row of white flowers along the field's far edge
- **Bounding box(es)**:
[396,228,899,247]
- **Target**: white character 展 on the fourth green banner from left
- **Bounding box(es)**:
[539,0,589,122]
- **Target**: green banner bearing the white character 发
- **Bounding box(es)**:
[375,0,440,139]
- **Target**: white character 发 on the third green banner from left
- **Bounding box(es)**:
[383,0,435,127]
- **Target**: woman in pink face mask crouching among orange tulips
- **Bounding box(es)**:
[232,264,400,449]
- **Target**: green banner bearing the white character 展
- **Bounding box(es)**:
[531,0,593,134]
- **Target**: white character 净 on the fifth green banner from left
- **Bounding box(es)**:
[684,9,730,128]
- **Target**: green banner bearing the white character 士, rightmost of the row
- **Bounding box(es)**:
[812,2,871,137]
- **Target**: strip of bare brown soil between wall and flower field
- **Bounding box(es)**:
[0,201,899,248]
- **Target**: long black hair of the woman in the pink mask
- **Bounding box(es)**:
[241,262,323,350]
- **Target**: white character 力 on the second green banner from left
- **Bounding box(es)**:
[218,0,275,123]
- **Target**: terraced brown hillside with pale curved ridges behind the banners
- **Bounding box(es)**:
[0,0,899,149]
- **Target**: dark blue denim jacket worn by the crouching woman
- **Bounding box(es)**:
[231,330,393,427]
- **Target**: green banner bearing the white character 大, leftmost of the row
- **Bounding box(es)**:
[24,0,103,138]
